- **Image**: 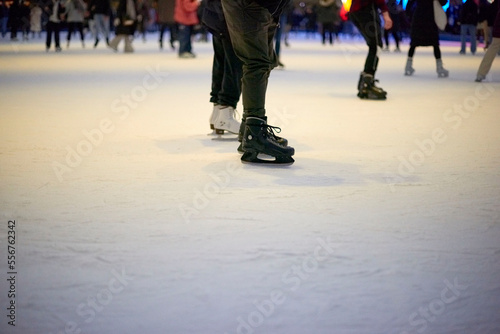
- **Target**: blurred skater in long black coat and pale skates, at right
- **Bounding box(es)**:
[405,0,449,78]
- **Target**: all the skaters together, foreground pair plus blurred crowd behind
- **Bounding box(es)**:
[0,0,500,165]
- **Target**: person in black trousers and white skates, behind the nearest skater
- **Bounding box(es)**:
[202,0,242,134]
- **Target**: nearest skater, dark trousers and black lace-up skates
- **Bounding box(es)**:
[222,0,295,165]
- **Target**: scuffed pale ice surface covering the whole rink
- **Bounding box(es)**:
[0,33,500,334]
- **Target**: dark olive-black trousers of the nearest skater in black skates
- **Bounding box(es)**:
[222,0,278,119]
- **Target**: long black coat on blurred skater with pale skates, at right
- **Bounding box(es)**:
[408,0,448,46]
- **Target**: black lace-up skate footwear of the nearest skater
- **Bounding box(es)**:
[241,117,295,166]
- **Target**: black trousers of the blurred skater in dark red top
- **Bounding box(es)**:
[349,6,382,75]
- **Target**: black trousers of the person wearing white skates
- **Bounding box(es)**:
[210,34,243,109]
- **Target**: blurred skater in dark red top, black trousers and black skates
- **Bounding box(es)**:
[349,0,392,100]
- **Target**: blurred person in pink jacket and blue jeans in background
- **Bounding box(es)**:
[174,0,200,58]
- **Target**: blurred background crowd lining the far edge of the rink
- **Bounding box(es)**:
[0,0,499,52]
